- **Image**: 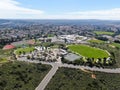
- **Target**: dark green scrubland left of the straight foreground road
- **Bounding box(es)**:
[0,61,51,90]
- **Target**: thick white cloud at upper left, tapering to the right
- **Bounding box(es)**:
[0,0,44,18]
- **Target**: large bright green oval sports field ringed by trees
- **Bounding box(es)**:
[68,45,109,59]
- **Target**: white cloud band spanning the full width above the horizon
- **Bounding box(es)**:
[0,0,120,20]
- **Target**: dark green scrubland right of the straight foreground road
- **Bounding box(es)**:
[45,68,120,90]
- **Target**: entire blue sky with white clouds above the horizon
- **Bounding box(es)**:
[0,0,120,20]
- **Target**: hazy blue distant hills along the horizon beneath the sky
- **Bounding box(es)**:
[0,19,120,25]
